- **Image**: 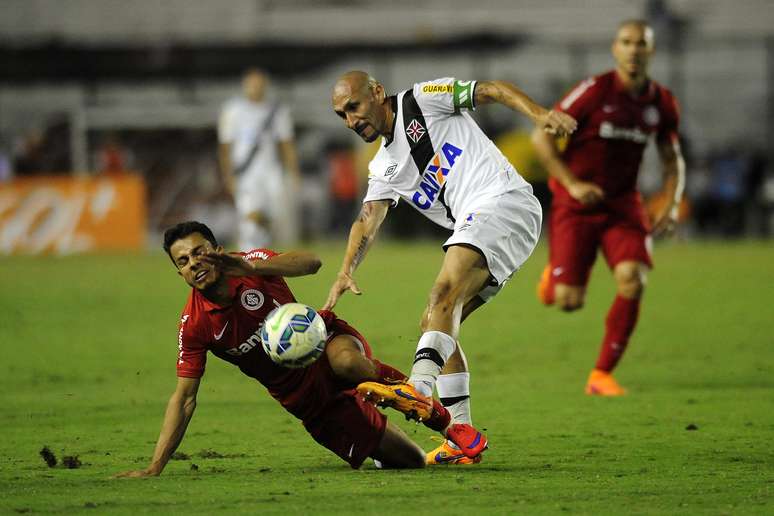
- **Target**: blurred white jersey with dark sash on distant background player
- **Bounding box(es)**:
[218,97,293,183]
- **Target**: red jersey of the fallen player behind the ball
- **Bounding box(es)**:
[177,249,331,421]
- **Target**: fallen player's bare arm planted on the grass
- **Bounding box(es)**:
[116,378,200,478]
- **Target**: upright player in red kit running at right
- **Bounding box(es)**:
[533,20,685,396]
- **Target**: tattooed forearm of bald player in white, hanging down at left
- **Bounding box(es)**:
[323,201,390,310]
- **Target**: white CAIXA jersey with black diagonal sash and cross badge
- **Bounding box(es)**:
[363,78,531,229]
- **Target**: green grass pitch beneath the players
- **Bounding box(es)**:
[0,242,774,514]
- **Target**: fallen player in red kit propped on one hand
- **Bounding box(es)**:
[118,222,480,477]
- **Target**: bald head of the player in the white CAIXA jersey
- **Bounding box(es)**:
[331,70,392,142]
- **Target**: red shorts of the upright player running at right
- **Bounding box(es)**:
[548,195,653,286]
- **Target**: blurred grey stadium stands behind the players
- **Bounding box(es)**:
[0,0,774,250]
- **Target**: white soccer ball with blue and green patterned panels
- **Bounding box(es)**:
[261,303,328,368]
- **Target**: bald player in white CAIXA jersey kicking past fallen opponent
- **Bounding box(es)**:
[325,71,575,464]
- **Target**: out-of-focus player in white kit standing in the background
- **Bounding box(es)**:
[218,69,300,249]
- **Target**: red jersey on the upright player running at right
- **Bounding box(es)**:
[549,71,680,206]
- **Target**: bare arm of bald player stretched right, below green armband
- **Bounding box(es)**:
[474,81,578,136]
